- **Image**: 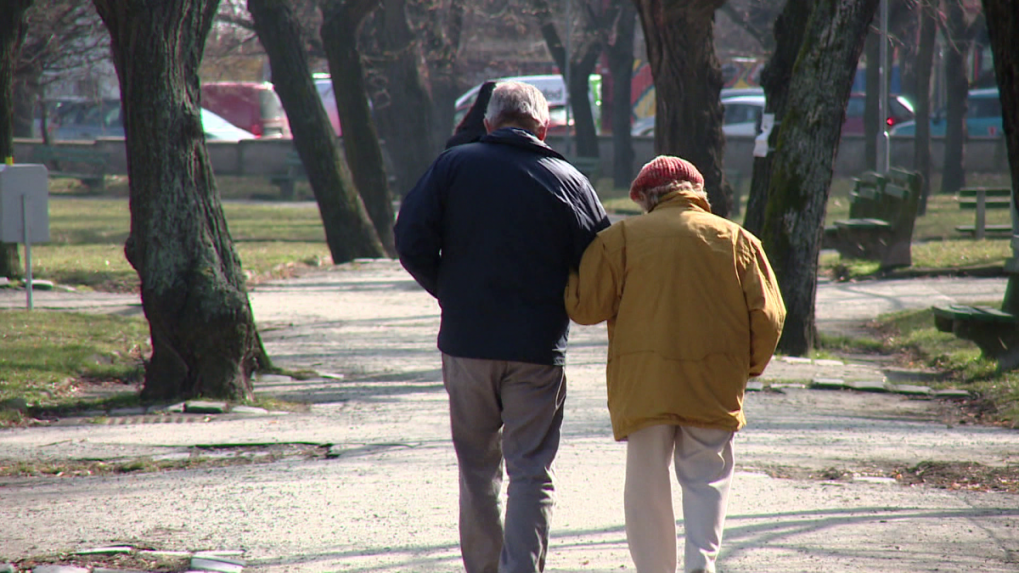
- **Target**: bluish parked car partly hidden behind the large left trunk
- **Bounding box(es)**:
[49,99,255,141]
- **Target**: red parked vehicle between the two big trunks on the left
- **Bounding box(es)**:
[202,82,290,138]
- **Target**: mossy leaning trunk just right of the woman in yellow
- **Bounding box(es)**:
[761,0,877,356]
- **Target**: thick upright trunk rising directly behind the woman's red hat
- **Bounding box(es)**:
[634,0,733,217]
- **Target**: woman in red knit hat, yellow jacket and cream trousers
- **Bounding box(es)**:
[566,156,786,573]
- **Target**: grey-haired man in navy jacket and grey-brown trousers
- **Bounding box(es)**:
[395,82,608,573]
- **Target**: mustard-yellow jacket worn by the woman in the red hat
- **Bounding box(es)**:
[566,189,786,440]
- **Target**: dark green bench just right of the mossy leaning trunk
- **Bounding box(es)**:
[825,169,920,269]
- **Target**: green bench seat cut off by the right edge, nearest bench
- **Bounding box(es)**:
[931,305,1019,370]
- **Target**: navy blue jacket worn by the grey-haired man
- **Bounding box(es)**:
[395,127,608,365]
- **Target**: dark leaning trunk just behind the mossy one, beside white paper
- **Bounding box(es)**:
[743,0,813,236]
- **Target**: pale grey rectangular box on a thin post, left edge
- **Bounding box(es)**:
[0,163,50,244]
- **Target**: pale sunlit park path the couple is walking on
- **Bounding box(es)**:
[0,261,1019,573]
